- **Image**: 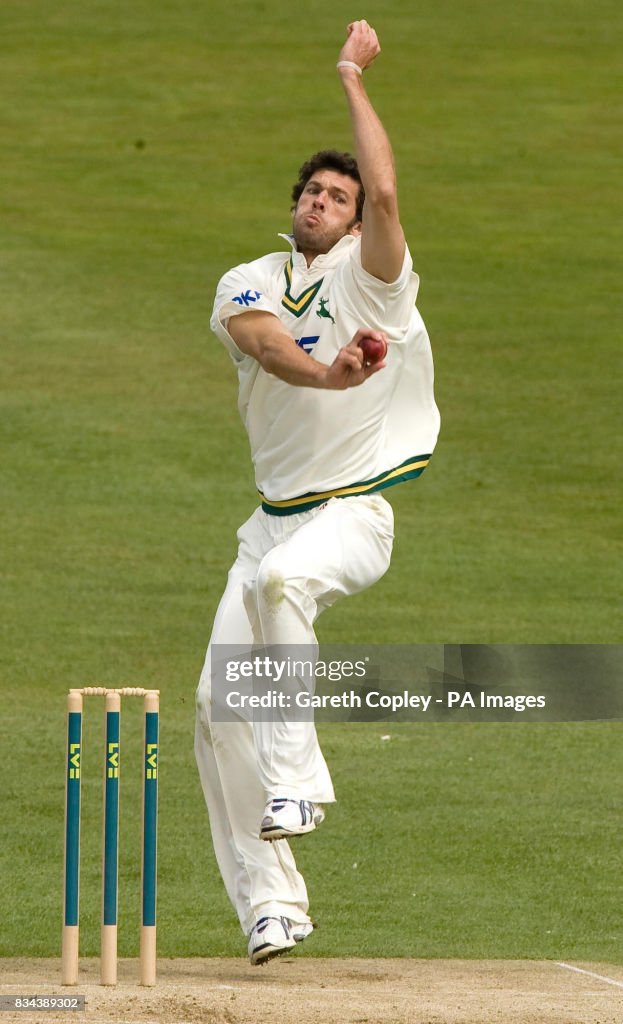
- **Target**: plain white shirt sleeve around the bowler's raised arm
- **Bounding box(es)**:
[340,239,419,341]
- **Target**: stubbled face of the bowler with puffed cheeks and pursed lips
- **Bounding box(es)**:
[292,170,361,258]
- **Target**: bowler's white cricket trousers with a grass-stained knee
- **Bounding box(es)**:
[195,495,393,934]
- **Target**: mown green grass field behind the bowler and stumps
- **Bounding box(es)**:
[0,0,623,961]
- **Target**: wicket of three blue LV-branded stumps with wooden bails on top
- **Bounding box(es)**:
[61,686,160,985]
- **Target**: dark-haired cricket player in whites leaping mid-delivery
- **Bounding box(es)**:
[196,20,440,964]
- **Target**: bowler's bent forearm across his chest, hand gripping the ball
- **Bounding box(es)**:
[227,311,386,391]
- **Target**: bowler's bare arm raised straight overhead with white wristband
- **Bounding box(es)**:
[338,22,405,283]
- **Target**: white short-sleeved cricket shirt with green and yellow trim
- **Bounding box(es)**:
[211,234,440,515]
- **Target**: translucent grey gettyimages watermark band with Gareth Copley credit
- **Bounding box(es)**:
[211,644,623,722]
